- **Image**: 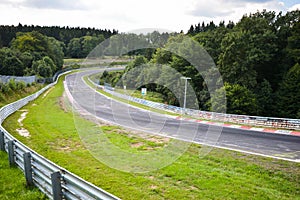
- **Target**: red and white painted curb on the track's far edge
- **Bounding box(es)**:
[175,116,300,136]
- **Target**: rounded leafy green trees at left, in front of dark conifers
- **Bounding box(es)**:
[0,31,64,78]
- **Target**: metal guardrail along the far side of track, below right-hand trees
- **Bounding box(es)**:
[89,79,300,130]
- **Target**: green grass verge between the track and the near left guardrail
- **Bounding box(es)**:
[4,74,300,199]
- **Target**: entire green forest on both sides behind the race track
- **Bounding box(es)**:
[0,10,300,118]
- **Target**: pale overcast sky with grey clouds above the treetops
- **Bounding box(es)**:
[0,0,300,32]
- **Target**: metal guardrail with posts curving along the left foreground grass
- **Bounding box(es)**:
[0,71,119,200]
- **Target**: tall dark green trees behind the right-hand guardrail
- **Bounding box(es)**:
[102,10,300,118]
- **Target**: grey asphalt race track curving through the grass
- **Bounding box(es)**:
[66,70,300,162]
